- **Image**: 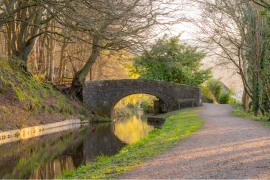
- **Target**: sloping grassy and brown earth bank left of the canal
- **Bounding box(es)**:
[0,60,87,131]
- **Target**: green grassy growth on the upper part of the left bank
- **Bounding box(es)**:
[0,59,75,114]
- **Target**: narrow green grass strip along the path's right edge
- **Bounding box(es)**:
[233,105,270,127]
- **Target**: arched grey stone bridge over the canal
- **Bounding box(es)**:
[83,79,202,117]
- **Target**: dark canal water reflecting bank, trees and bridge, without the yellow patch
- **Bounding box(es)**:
[0,124,124,180]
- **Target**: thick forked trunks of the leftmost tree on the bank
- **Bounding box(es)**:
[5,1,42,74]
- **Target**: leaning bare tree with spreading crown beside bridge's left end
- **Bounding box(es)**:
[59,0,185,97]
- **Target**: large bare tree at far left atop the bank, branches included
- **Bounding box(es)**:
[0,0,55,71]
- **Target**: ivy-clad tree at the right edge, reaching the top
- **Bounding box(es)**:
[248,0,270,115]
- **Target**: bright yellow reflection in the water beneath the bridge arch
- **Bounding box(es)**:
[113,111,154,144]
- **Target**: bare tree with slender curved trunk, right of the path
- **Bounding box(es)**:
[192,0,258,107]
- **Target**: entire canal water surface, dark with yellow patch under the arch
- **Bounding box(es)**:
[0,111,154,180]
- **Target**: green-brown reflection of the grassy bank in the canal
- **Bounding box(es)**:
[0,129,79,180]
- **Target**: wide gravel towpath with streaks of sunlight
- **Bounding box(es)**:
[117,104,270,180]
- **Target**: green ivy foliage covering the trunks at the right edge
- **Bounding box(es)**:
[244,9,270,115]
